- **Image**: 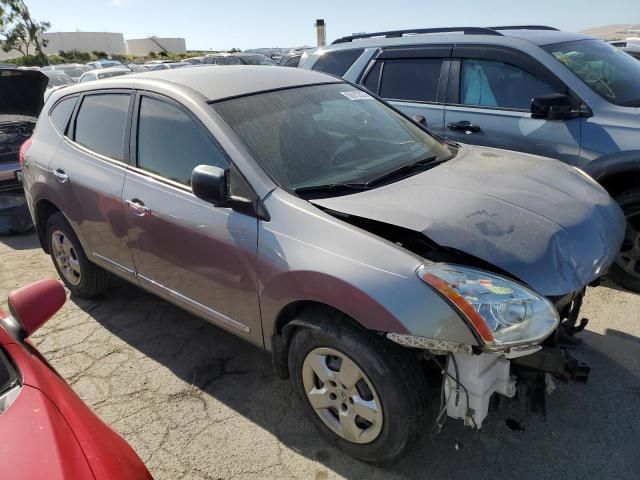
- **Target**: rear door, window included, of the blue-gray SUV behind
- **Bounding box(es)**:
[361,45,453,134]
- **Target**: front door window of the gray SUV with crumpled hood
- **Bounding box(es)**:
[137,97,229,185]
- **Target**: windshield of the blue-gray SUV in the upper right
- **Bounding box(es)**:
[544,40,640,107]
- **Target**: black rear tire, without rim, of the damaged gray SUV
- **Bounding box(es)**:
[46,212,109,298]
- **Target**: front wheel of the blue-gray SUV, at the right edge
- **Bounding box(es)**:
[609,190,640,292]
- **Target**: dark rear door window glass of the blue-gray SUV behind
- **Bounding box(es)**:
[380,58,443,102]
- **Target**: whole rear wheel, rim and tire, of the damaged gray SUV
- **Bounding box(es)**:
[47,213,109,298]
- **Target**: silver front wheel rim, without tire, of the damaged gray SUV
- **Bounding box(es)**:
[302,348,383,444]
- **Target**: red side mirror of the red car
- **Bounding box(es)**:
[2,279,67,341]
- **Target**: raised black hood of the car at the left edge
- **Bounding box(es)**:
[0,69,49,121]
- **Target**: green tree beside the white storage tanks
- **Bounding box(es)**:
[0,0,51,65]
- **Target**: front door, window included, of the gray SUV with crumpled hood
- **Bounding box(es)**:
[123,94,263,346]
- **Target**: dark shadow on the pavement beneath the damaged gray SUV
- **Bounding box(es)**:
[72,285,640,480]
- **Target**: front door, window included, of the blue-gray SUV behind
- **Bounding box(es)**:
[445,45,580,164]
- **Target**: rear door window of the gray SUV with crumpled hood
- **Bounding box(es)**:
[75,93,130,160]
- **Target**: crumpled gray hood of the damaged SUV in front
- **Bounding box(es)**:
[312,146,625,296]
